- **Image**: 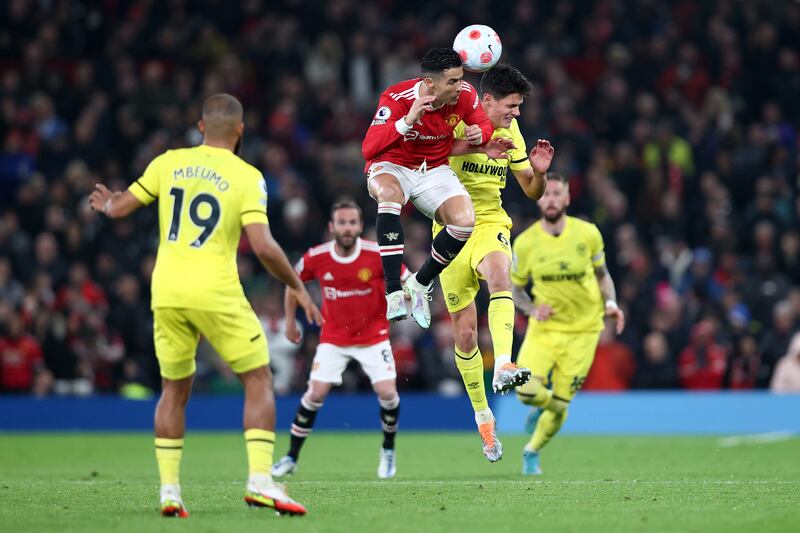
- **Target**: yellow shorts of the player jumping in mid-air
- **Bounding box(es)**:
[439,224,511,313]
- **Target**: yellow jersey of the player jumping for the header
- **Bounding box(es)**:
[450,119,531,227]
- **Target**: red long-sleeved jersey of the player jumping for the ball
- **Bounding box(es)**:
[361,78,494,169]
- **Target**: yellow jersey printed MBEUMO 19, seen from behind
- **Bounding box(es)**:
[128,145,268,310]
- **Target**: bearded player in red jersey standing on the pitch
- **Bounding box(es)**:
[272,200,400,478]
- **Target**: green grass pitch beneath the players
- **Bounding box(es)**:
[0,432,800,533]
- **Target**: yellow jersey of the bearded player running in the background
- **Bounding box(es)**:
[511,216,605,332]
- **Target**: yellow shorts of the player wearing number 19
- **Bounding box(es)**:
[153,302,269,380]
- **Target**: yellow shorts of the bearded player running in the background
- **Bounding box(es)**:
[517,326,600,401]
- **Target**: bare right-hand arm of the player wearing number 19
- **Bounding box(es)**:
[244,223,322,325]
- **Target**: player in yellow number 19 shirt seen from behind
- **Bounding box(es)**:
[89,94,322,517]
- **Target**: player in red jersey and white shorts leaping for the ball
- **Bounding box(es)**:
[362,48,494,328]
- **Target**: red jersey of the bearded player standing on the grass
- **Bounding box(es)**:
[295,239,405,346]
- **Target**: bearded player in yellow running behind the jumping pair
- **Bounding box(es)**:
[511,173,625,474]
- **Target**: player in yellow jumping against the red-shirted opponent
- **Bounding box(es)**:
[440,63,554,462]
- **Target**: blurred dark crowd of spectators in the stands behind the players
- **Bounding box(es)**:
[0,0,800,396]
